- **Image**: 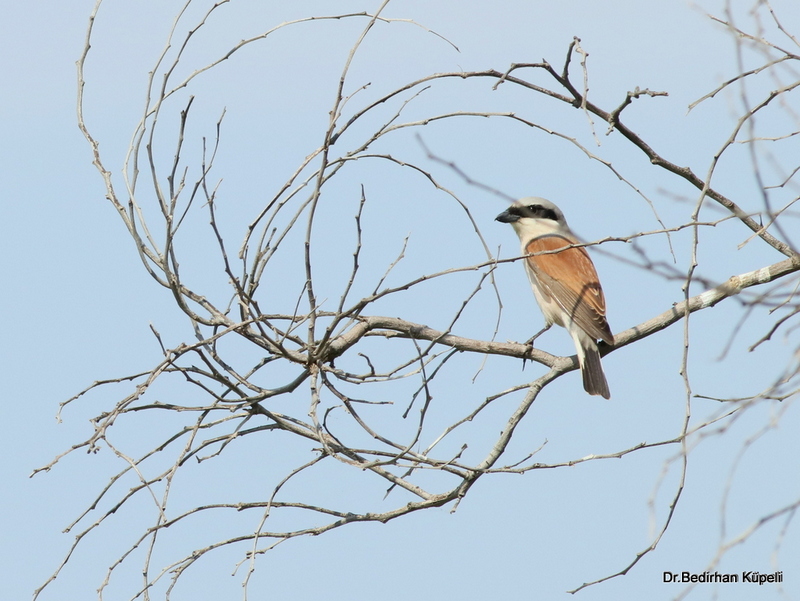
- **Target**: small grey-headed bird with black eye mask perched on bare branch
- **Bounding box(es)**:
[495,196,614,399]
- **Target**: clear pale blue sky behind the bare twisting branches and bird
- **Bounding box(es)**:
[0,0,800,601]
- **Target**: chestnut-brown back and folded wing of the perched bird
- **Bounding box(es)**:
[525,234,614,344]
